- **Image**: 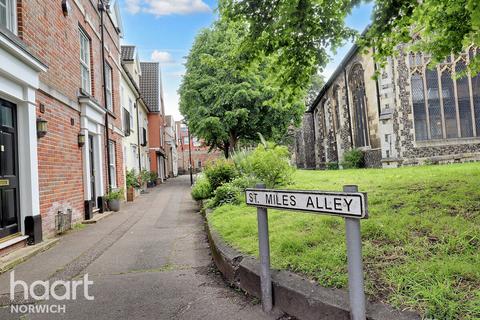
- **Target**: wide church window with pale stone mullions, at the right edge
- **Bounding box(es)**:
[410,49,480,141]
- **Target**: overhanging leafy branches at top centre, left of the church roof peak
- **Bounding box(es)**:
[219,0,360,97]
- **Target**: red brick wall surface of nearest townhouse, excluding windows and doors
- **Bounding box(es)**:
[17,0,124,235]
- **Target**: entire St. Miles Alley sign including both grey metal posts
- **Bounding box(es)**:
[245,184,368,320]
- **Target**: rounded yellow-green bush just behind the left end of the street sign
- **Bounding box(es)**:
[247,143,294,188]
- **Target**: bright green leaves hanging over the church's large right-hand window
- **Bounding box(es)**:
[361,0,480,74]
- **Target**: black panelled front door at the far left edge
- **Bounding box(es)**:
[0,99,20,238]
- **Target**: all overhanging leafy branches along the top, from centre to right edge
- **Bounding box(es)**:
[219,0,480,93]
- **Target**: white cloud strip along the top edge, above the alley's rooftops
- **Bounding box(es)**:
[126,0,211,17]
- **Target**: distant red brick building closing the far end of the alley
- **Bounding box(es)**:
[176,121,224,174]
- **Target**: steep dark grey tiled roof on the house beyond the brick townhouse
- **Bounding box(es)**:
[140,62,160,112]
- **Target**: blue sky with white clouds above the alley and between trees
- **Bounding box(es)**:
[120,0,373,120]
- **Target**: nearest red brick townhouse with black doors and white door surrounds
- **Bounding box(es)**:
[0,0,124,242]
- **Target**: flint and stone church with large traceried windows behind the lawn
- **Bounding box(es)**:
[295,46,480,169]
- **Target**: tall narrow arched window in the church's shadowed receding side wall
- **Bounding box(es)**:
[350,64,368,147]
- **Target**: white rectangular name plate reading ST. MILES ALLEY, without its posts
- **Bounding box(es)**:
[245,189,368,219]
